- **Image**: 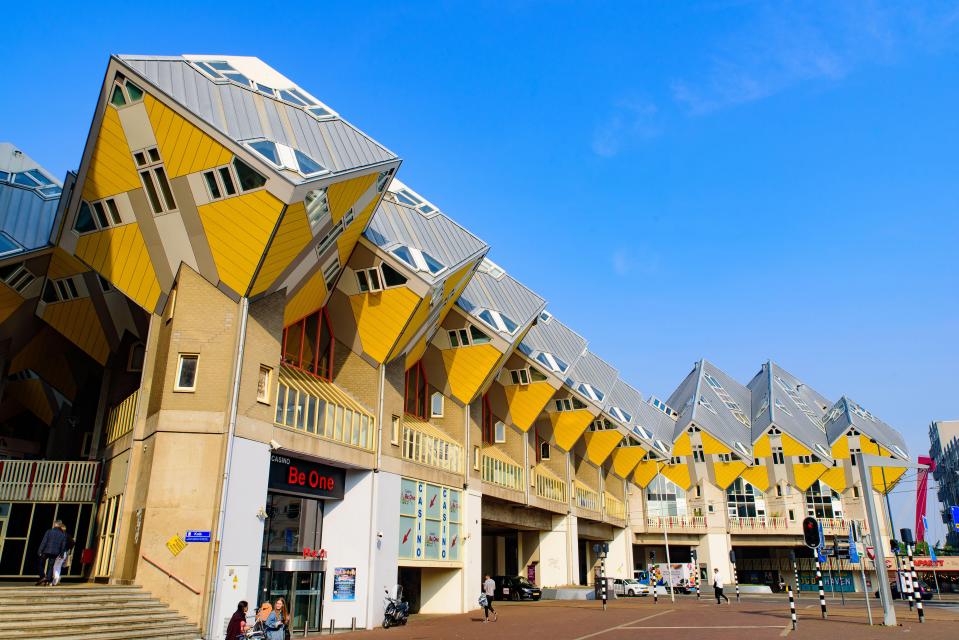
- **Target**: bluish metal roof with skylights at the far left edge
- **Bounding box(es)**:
[0,142,61,257]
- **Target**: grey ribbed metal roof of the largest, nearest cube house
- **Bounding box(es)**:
[118,56,396,178]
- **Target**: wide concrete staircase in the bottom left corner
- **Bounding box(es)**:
[0,584,200,640]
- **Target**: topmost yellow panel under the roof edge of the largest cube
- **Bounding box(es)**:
[142,94,233,178]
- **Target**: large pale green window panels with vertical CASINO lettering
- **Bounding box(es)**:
[399,478,461,561]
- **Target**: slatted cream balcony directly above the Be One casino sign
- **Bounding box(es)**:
[275,367,376,451]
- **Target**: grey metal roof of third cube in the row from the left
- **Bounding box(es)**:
[456,258,546,343]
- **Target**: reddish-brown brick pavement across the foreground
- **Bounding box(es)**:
[311,597,959,640]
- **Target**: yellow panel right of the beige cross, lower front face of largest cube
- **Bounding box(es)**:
[197,189,283,294]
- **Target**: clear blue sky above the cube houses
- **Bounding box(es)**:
[0,0,959,532]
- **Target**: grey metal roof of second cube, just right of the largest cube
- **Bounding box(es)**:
[364,198,489,282]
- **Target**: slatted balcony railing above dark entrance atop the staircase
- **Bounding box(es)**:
[0,460,100,502]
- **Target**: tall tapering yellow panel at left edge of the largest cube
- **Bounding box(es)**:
[83,107,142,201]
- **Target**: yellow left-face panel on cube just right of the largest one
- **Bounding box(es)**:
[350,287,420,363]
